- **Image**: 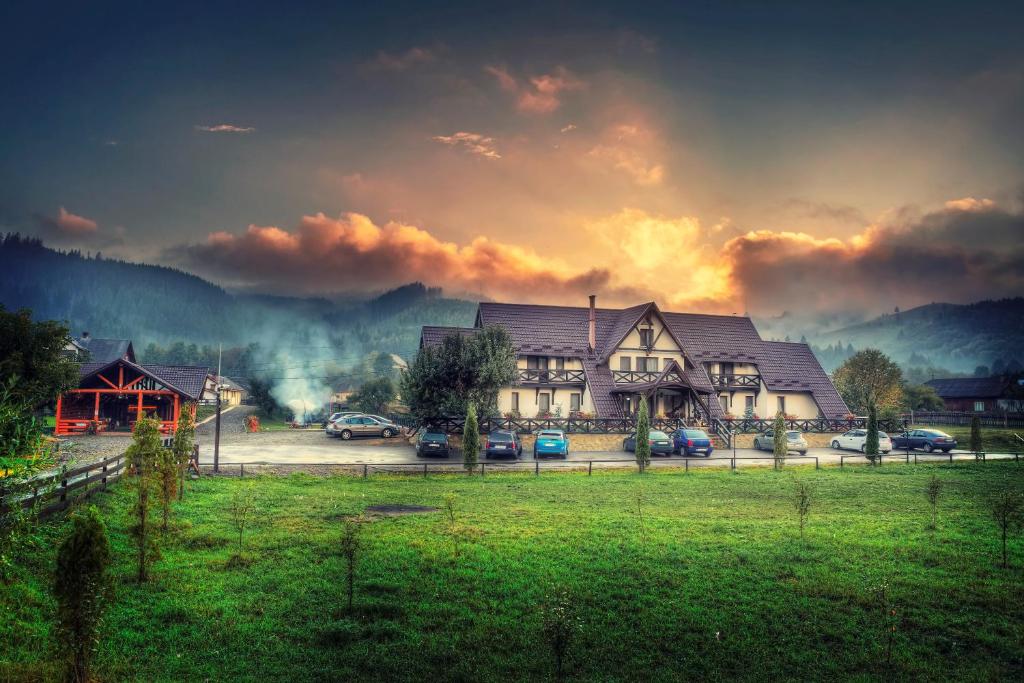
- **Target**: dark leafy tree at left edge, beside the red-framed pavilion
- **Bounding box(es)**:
[0,304,78,409]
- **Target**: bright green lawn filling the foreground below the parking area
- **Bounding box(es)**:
[0,462,1024,681]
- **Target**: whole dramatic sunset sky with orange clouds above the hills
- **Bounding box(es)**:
[0,2,1024,315]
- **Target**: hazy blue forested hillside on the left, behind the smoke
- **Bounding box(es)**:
[0,234,476,362]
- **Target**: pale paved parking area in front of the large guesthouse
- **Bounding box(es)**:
[193,430,1015,467]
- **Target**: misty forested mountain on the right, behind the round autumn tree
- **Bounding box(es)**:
[808,298,1024,373]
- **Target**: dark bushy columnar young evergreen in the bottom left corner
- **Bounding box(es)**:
[53,506,111,683]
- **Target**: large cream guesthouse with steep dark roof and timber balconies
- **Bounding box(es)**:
[420,296,849,421]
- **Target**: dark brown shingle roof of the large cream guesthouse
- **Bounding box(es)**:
[421,302,849,418]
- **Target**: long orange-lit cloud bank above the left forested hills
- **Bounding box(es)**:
[166,213,651,303]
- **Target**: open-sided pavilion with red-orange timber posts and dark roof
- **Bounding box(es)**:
[54,334,214,435]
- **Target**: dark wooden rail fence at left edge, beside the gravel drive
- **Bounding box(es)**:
[0,455,125,517]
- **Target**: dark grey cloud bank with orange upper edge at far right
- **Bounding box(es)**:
[723,198,1024,312]
